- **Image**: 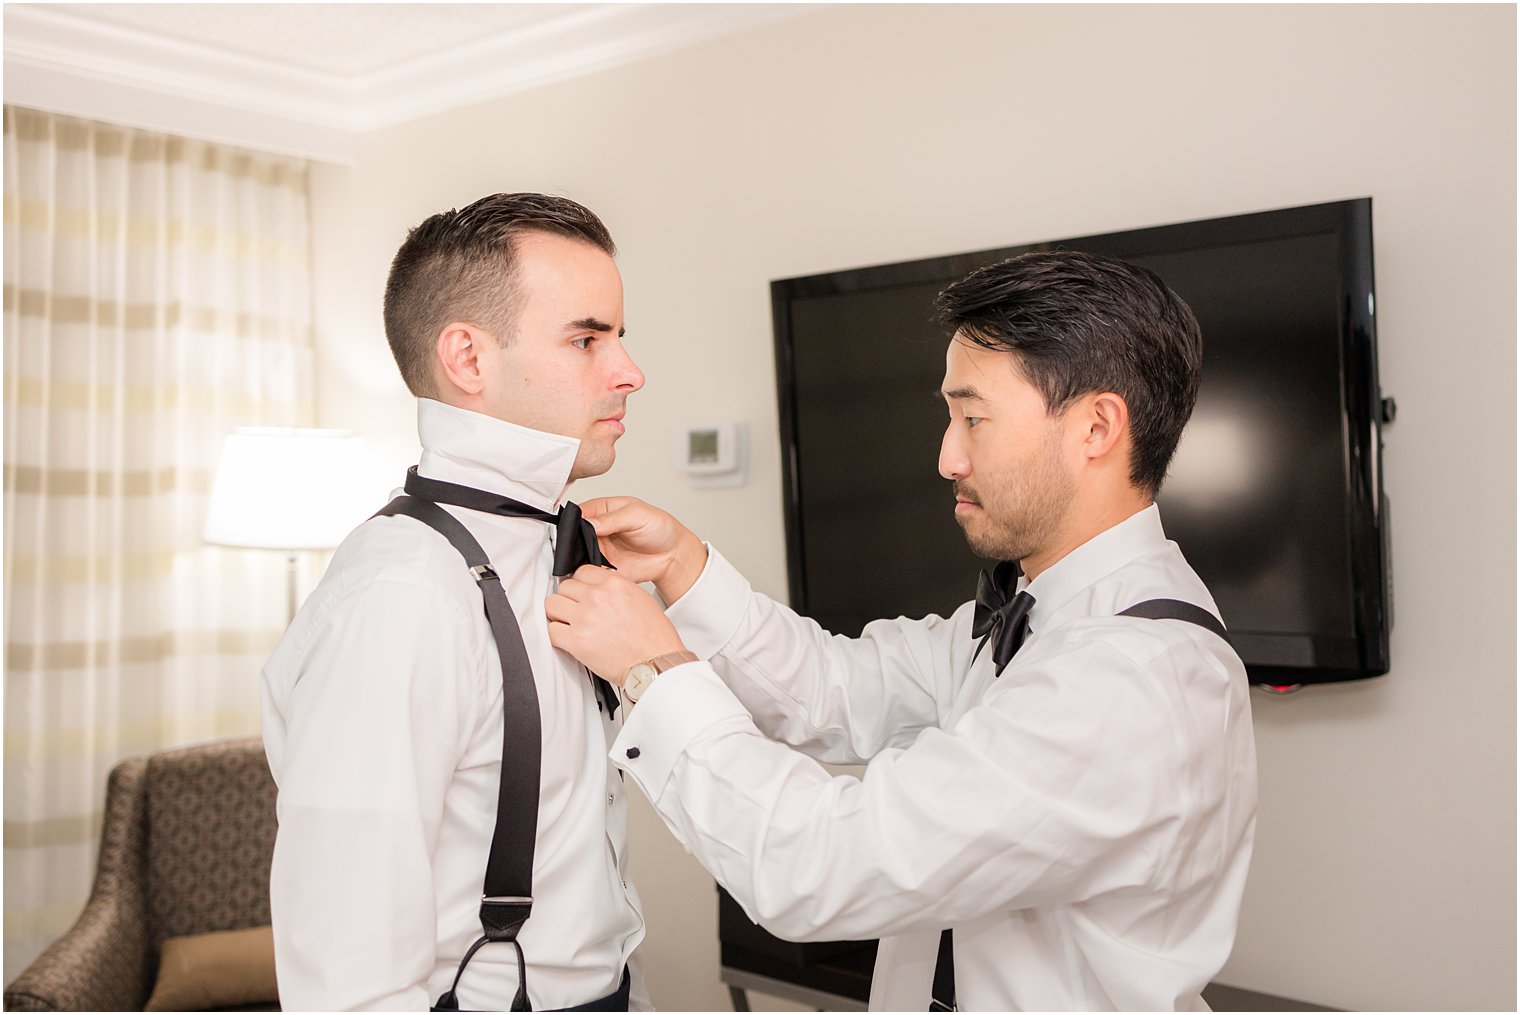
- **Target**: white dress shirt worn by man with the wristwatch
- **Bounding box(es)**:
[613,506,1256,1012]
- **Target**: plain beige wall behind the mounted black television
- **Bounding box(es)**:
[313,6,1515,1009]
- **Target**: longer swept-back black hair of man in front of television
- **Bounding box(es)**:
[935,251,1204,497]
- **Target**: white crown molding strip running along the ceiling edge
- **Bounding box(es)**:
[5,3,827,164]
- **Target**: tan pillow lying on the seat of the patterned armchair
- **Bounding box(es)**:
[143,927,280,1012]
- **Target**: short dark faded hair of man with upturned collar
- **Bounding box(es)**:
[385,193,617,398]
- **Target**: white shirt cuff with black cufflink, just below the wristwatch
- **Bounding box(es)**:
[608,662,754,801]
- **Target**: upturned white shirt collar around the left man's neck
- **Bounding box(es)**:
[416,398,581,511]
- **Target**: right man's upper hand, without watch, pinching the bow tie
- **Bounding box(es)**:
[581,497,707,601]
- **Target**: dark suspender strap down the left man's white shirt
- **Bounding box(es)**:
[375,497,543,1012]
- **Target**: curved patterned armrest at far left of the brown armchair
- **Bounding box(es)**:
[5,758,157,1012]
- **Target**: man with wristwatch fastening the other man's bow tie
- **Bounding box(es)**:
[547,251,1257,1010]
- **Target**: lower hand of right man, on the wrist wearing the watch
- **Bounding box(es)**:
[544,568,701,687]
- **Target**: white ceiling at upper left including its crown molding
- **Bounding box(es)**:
[5,3,821,163]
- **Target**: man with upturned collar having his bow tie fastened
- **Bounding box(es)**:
[263,194,649,1010]
